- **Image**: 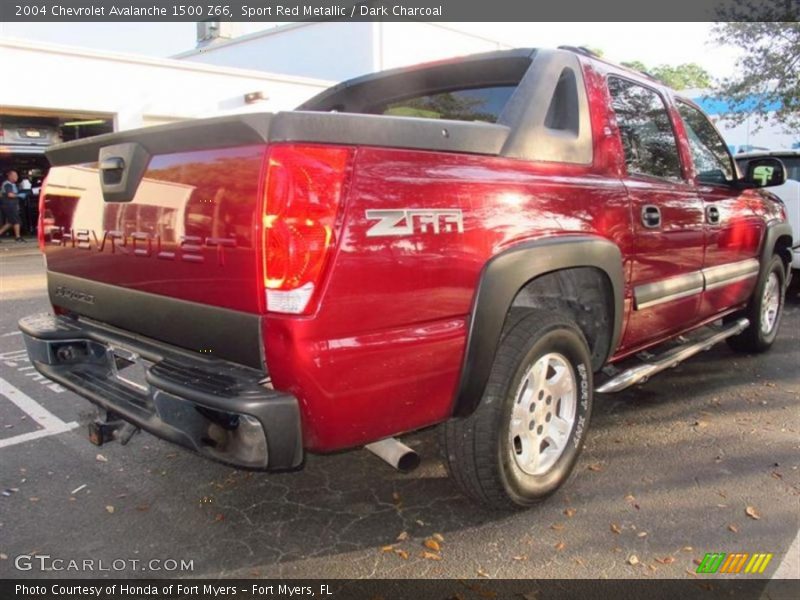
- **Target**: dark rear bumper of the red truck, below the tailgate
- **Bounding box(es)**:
[19,314,303,470]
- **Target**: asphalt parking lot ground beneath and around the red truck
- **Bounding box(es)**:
[0,243,800,578]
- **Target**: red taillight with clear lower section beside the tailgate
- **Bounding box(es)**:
[263,144,353,314]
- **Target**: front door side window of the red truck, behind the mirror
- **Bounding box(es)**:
[678,102,733,183]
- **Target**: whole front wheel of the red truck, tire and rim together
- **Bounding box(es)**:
[726,256,786,353]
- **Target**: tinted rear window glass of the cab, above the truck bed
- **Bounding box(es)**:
[368,85,517,123]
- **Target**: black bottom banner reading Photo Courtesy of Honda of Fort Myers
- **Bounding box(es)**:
[0,576,800,600]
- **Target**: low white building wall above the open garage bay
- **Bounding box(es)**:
[0,38,331,130]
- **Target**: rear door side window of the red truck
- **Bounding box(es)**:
[608,77,681,180]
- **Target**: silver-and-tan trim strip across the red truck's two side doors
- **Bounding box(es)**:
[633,258,760,310]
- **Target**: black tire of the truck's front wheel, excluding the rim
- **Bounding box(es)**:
[725,256,786,354]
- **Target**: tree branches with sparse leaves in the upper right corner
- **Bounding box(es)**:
[713,22,800,131]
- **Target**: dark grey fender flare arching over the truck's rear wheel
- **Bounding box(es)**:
[453,235,625,417]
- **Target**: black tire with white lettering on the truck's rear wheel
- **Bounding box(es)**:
[440,309,593,510]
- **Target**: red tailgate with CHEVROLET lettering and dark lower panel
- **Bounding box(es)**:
[42,118,266,367]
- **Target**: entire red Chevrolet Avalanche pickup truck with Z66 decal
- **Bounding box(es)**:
[20,48,792,508]
